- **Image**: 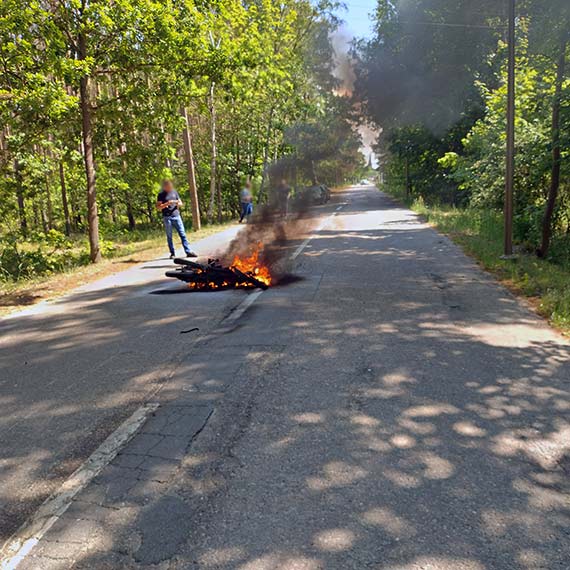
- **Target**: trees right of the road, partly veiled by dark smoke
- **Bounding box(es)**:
[356,0,570,263]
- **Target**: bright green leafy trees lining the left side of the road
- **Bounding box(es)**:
[0,0,360,275]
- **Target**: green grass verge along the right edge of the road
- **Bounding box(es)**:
[400,197,570,335]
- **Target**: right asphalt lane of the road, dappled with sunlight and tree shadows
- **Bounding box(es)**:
[5,189,570,570]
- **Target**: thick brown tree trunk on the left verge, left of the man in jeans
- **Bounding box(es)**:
[79,33,102,263]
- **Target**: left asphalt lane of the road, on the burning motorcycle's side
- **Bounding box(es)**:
[0,221,244,543]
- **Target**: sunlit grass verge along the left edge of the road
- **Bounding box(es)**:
[0,222,235,315]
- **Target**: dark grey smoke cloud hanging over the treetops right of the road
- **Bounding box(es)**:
[355,0,502,133]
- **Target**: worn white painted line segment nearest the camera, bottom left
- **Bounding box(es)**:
[0,403,159,570]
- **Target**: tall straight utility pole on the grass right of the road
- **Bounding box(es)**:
[504,0,516,257]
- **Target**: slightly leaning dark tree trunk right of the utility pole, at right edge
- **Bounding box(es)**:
[538,30,568,257]
